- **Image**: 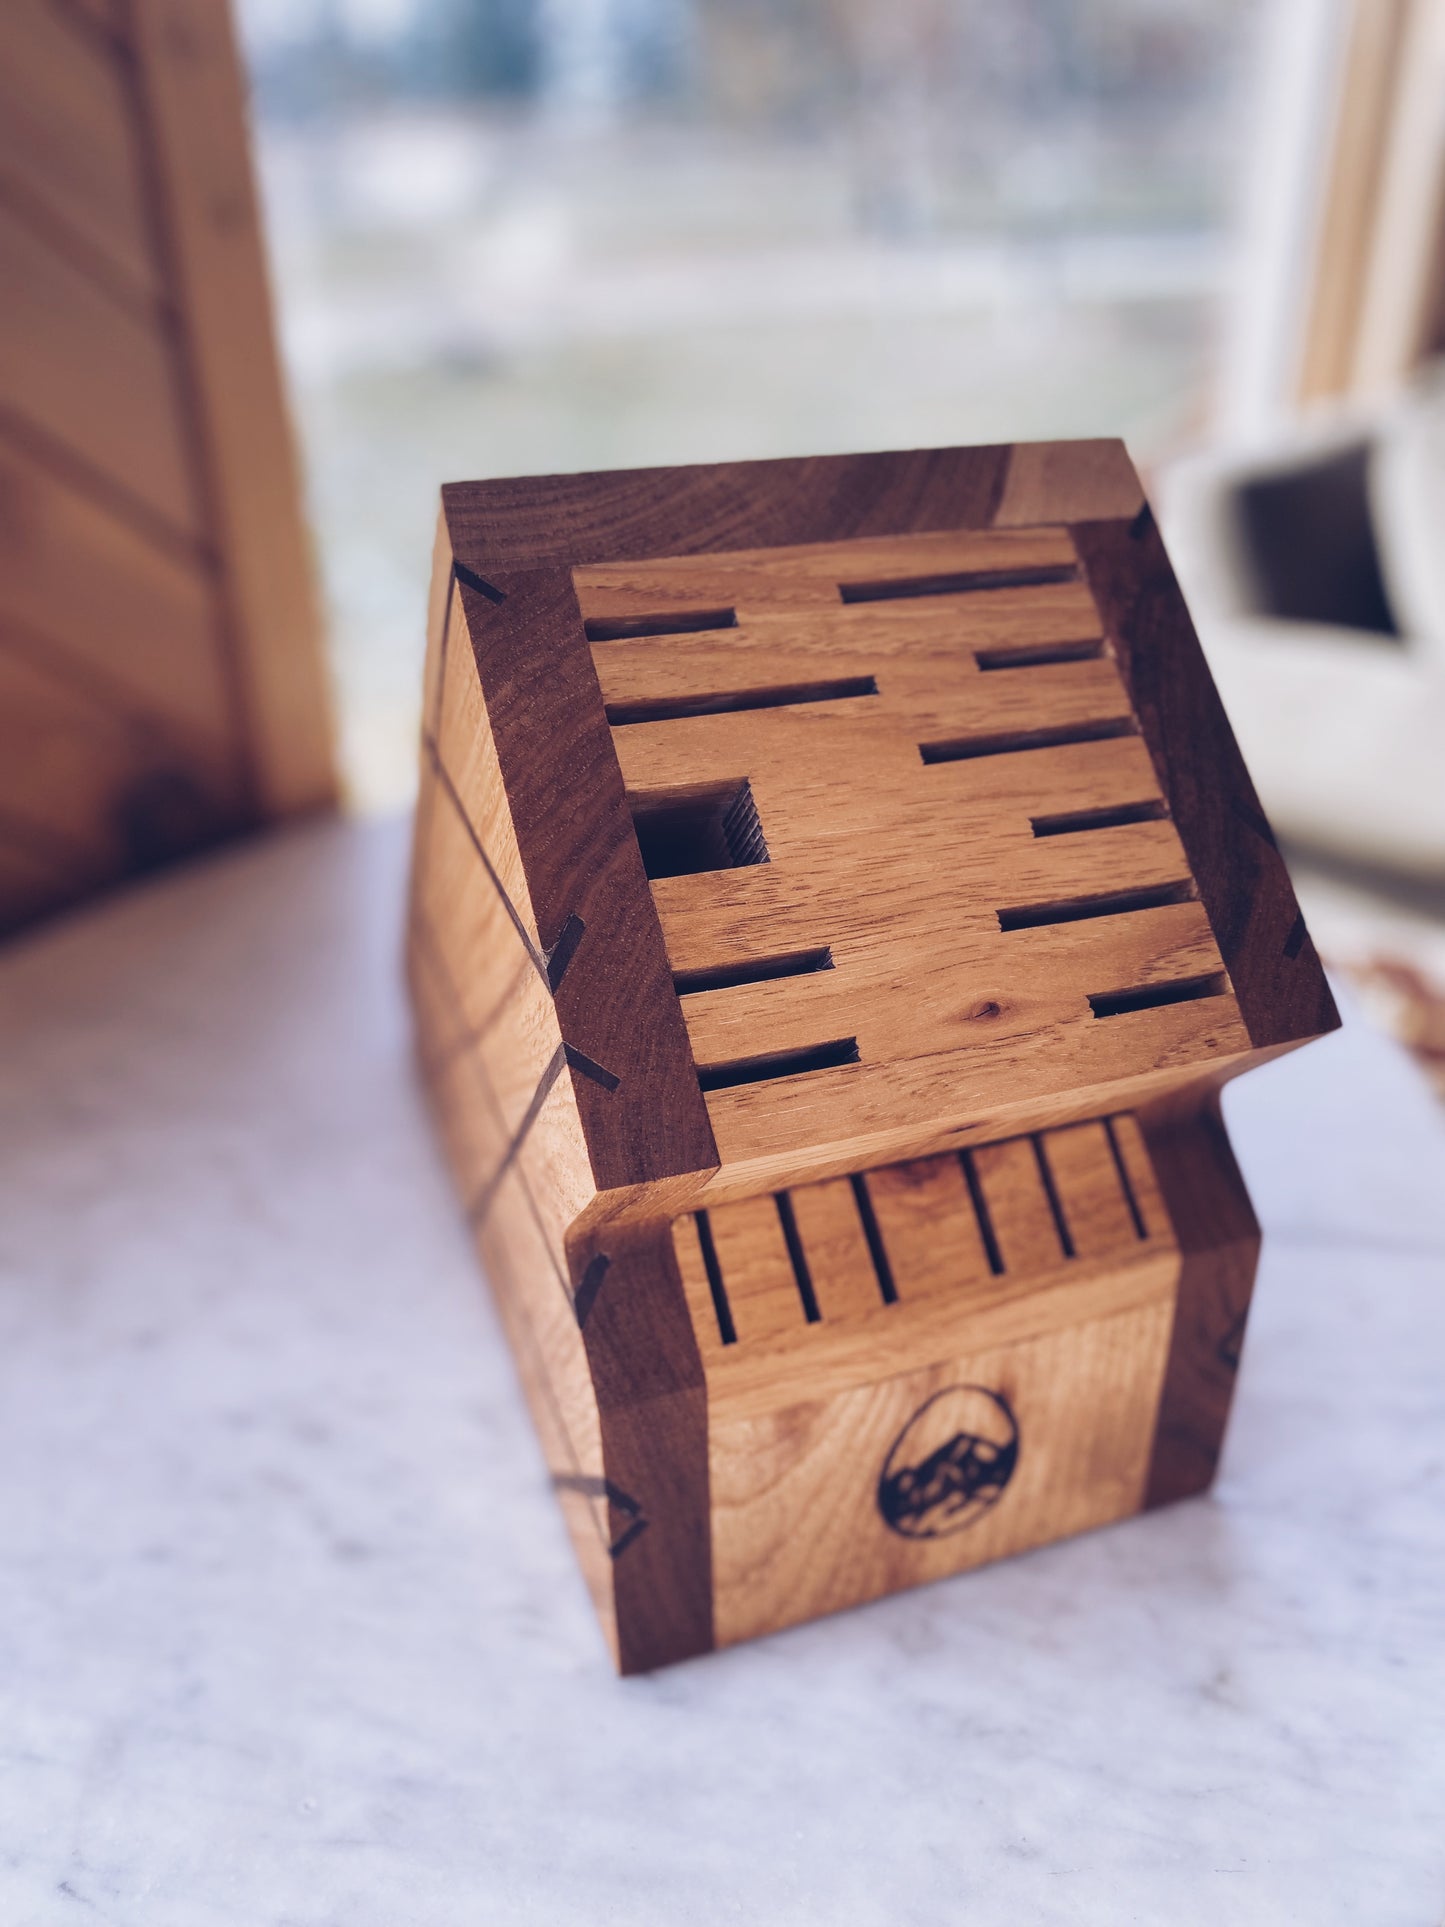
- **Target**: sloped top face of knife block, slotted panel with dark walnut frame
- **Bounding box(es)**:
[443,443,1335,1197]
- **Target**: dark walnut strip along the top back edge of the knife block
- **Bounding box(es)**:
[441,445,1012,584]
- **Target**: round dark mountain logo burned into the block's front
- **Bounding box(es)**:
[879,1386,1019,1540]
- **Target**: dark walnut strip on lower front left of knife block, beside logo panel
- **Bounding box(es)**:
[568,1222,713,1673]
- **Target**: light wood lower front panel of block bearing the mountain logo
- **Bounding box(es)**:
[709,1291,1169,1646]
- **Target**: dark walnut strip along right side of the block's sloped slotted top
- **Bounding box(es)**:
[1071,511,1339,1048]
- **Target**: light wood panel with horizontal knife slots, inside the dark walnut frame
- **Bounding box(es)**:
[593,527,1247,1195]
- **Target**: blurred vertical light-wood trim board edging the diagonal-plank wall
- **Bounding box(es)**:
[131,0,335,817]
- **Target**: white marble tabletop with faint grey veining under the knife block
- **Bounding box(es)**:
[0,825,1445,1927]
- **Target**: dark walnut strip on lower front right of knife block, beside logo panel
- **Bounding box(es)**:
[1139,1093,1260,1505]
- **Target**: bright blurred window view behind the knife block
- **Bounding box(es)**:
[239,0,1262,805]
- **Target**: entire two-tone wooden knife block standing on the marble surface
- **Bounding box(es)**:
[408,441,1339,1673]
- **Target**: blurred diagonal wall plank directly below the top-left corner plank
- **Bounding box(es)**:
[0,202,206,545]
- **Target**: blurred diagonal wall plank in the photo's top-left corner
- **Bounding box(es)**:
[0,0,164,308]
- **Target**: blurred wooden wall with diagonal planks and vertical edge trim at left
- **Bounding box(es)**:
[0,0,335,935]
